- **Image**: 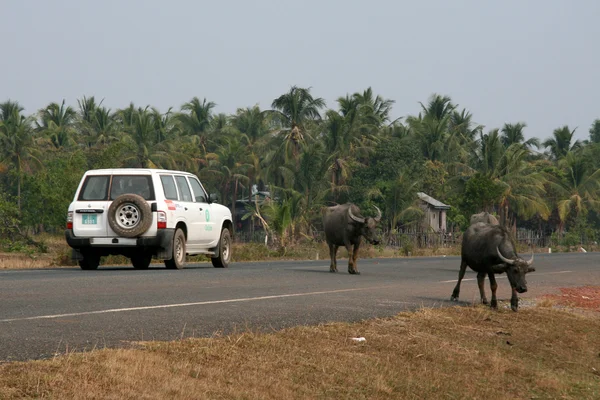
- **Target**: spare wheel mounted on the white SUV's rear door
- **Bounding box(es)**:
[108,193,152,238]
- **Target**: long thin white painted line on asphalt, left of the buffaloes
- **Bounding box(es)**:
[0,285,393,322]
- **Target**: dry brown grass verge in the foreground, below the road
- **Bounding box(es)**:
[0,306,600,399]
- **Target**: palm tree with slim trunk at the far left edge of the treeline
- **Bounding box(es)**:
[0,105,42,213]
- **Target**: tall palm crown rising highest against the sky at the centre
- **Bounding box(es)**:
[271,86,325,160]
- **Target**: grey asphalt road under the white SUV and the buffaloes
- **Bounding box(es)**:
[0,253,600,362]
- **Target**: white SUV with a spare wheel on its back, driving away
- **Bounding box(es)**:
[65,168,233,270]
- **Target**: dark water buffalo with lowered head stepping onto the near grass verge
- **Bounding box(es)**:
[450,222,535,311]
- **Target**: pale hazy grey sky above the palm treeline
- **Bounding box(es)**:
[0,0,600,139]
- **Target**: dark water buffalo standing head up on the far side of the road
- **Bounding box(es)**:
[323,203,381,274]
